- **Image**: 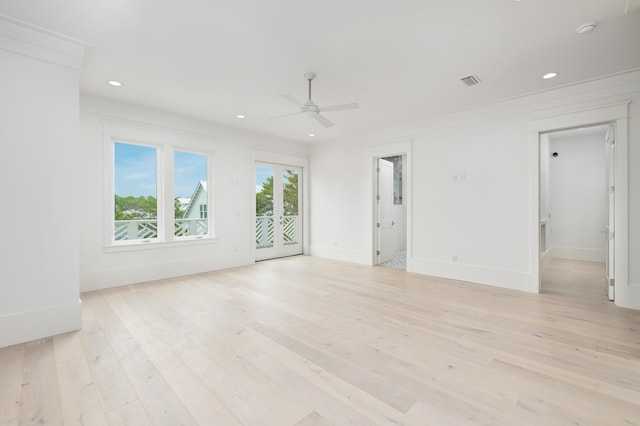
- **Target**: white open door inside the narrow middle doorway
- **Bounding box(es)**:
[376,158,395,263]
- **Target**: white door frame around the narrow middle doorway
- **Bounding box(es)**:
[370,141,413,271]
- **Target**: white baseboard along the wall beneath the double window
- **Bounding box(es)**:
[80,253,254,293]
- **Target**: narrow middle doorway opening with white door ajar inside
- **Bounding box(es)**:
[375,155,407,269]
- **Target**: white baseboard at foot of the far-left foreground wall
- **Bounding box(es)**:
[0,300,82,348]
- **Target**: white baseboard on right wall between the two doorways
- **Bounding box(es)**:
[407,257,538,293]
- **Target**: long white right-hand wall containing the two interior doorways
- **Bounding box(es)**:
[311,71,640,308]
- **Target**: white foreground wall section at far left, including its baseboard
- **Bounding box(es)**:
[0,18,83,347]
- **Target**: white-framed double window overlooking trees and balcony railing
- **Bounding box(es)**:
[105,137,213,245]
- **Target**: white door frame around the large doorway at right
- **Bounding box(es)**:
[529,102,630,306]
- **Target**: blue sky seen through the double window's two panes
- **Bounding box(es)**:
[114,143,207,197]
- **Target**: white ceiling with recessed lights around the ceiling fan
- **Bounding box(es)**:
[0,0,640,142]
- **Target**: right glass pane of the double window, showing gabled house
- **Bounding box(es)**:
[173,151,209,237]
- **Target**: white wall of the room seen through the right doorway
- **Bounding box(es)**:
[549,127,607,262]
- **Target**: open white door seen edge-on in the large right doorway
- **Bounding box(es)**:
[605,124,616,300]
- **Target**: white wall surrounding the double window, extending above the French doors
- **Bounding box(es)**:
[80,96,308,291]
